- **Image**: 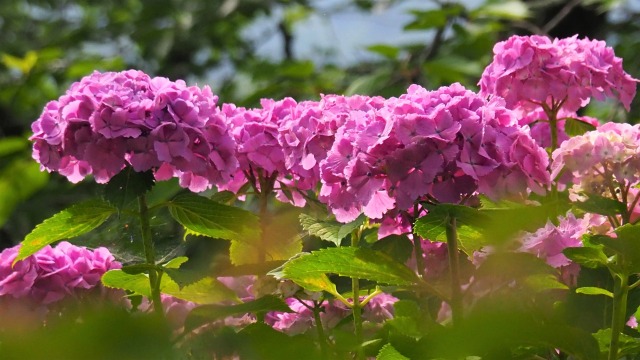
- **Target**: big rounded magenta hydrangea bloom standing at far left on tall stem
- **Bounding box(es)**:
[30,70,238,191]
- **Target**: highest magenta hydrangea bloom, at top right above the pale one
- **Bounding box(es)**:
[479,35,637,112]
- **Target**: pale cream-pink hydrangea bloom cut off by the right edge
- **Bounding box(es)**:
[551,123,640,204]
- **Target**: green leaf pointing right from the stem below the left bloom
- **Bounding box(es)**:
[169,193,260,241]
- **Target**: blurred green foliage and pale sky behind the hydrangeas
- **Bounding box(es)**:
[0,0,640,249]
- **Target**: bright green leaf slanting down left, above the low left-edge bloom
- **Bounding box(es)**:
[14,200,116,263]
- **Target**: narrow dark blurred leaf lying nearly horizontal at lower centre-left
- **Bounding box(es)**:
[184,295,292,332]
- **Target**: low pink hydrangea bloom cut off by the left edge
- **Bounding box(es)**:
[0,241,121,306]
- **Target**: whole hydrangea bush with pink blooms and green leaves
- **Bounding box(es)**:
[5,36,640,360]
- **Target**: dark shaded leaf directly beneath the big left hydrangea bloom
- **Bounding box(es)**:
[104,166,155,209]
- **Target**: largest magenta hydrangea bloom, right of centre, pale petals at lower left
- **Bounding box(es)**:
[319,84,549,222]
